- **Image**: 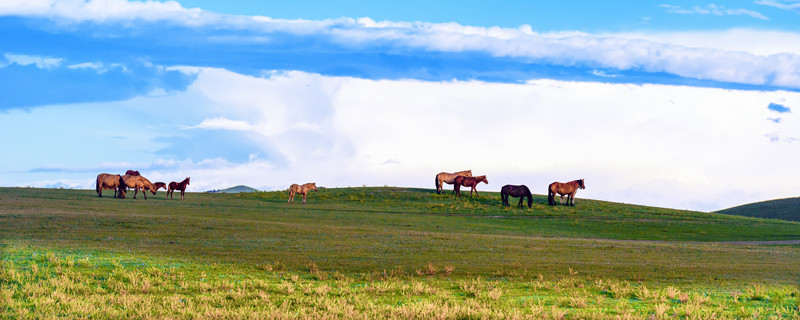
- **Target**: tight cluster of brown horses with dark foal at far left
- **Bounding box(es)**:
[95,170,189,200]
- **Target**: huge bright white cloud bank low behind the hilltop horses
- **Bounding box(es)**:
[125,69,800,210]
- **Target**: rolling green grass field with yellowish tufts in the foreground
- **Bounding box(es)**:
[0,187,800,319]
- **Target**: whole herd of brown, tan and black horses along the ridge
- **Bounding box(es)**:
[96,170,586,208]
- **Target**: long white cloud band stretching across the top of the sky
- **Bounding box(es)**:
[0,0,800,89]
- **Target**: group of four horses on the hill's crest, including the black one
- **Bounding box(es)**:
[434,170,586,208]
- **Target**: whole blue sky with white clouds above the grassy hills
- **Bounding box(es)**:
[0,0,800,211]
